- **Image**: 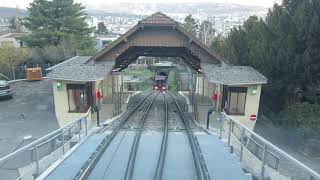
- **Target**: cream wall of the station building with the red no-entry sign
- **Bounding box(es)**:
[230,85,261,130]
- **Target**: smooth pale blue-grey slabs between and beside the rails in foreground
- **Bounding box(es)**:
[45,131,252,180]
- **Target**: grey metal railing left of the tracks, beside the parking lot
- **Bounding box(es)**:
[0,108,91,180]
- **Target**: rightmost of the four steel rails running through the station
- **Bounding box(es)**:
[168,91,210,180]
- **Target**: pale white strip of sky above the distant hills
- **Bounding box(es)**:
[0,0,281,9]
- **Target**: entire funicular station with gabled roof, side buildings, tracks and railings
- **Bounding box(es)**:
[0,13,320,180]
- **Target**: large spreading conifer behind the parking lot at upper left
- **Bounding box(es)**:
[22,0,95,52]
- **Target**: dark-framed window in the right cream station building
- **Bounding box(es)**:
[226,87,247,115]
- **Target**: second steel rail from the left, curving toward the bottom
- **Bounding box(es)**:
[124,92,160,180]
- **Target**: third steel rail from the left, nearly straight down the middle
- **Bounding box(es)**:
[154,92,169,180]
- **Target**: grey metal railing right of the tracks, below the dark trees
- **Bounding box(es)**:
[216,112,320,180]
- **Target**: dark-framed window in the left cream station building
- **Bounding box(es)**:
[67,84,90,113]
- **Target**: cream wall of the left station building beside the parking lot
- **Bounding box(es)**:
[52,80,90,127]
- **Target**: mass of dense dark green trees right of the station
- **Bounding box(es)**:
[211,0,320,112]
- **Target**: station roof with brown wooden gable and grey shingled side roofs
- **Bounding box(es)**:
[47,12,267,85]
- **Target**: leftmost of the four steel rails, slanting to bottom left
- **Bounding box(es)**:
[74,91,155,180]
